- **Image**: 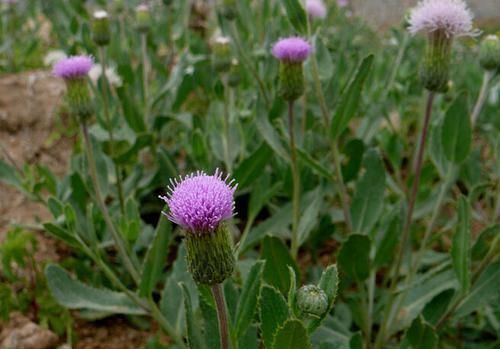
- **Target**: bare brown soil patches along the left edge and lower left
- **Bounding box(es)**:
[0,71,148,349]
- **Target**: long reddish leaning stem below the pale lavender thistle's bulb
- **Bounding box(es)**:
[375,92,435,349]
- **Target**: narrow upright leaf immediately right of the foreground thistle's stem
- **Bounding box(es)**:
[235,261,265,337]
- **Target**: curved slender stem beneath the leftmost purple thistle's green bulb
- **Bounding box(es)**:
[81,122,140,284]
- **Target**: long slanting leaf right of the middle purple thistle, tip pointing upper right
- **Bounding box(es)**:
[330,55,374,140]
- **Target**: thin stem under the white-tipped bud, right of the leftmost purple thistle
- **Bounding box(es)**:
[99,46,125,215]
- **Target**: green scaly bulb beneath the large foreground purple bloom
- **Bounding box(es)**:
[186,223,235,286]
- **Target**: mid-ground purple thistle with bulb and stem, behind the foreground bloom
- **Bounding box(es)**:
[272,37,311,257]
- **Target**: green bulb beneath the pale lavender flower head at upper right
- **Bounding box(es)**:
[421,30,452,92]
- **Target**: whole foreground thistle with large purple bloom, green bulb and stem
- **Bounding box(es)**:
[160,170,237,349]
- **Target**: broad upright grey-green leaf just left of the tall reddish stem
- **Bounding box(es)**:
[351,149,385,234]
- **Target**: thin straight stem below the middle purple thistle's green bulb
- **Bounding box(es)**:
[288,101,300,259]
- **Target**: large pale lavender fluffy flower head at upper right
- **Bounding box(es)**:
[408,0,479,38]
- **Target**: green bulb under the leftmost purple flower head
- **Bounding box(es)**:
[66,78,94,121]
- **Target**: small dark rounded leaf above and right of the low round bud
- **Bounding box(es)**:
[338,234,370,281]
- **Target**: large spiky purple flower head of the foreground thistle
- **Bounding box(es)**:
[160,170,237,234]
